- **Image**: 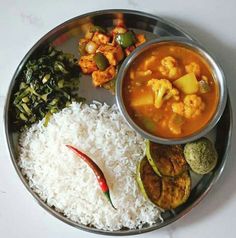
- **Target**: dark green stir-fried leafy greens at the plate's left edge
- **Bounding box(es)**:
[13,47,82,127]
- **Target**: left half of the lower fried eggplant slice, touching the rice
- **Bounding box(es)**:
[137,157,162,204]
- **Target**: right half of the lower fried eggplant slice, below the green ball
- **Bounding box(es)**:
[155,171,191,210]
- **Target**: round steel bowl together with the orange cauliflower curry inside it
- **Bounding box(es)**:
[116,37,227,144]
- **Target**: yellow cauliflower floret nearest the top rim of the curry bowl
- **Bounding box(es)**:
[159,56,181,79]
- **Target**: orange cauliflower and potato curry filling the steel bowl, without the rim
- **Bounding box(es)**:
[123,44,218,138]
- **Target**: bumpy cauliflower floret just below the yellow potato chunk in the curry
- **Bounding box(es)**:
[172,94,205,119]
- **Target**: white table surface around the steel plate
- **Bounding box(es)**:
[0,0,236,238]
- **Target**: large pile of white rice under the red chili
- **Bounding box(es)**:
[19,103,160,231]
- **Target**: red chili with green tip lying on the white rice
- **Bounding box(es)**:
[66,145,116,209]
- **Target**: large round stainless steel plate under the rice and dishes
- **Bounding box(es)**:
[4,10,232,235]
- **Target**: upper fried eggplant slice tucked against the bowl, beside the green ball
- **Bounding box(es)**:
[146,141,188,176]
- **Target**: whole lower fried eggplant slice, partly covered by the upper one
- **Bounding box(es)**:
[137,157,191,210]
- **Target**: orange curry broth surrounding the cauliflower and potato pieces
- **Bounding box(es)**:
[123,44,218,138]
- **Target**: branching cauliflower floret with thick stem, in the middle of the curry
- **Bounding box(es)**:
[147,79,179,108]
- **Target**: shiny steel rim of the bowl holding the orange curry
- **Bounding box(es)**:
[116,36,227,145]
